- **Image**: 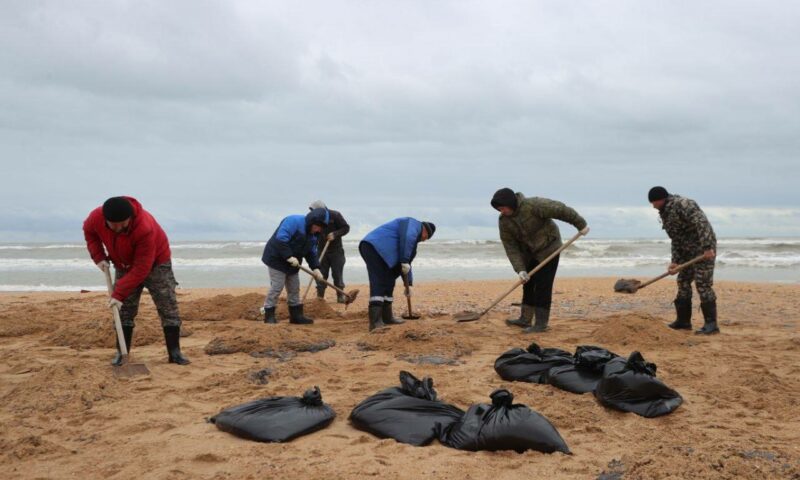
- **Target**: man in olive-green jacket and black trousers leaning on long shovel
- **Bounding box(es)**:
[491,188,589,333]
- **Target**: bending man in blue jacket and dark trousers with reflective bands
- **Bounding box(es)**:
[358,217,436,331]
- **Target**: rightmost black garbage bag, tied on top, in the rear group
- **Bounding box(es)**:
[594,352,683,418]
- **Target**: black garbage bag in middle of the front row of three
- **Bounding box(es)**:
[350,371,464,446]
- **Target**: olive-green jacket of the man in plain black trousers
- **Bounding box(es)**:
[498,192,586,272]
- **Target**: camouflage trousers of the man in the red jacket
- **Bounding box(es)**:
[114,262,181,327]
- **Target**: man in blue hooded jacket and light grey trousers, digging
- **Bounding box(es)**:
[261,208,329,325]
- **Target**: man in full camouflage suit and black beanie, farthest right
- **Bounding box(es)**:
[647,187,719,335]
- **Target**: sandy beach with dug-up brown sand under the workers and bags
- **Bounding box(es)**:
[0,278,800,479]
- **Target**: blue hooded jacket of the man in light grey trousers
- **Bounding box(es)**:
[261,208,330,275]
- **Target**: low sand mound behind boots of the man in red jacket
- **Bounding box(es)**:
[45,313,164,350]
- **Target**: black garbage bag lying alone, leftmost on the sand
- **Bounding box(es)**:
[209,387,336,442]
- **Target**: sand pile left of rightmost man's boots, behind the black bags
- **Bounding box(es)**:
[589,313,687,350]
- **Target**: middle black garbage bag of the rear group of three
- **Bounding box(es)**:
[547,345,619,393]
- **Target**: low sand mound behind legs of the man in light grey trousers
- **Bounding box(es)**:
[181,293,341,322]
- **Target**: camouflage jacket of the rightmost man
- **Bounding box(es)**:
[659,195,717,263]
